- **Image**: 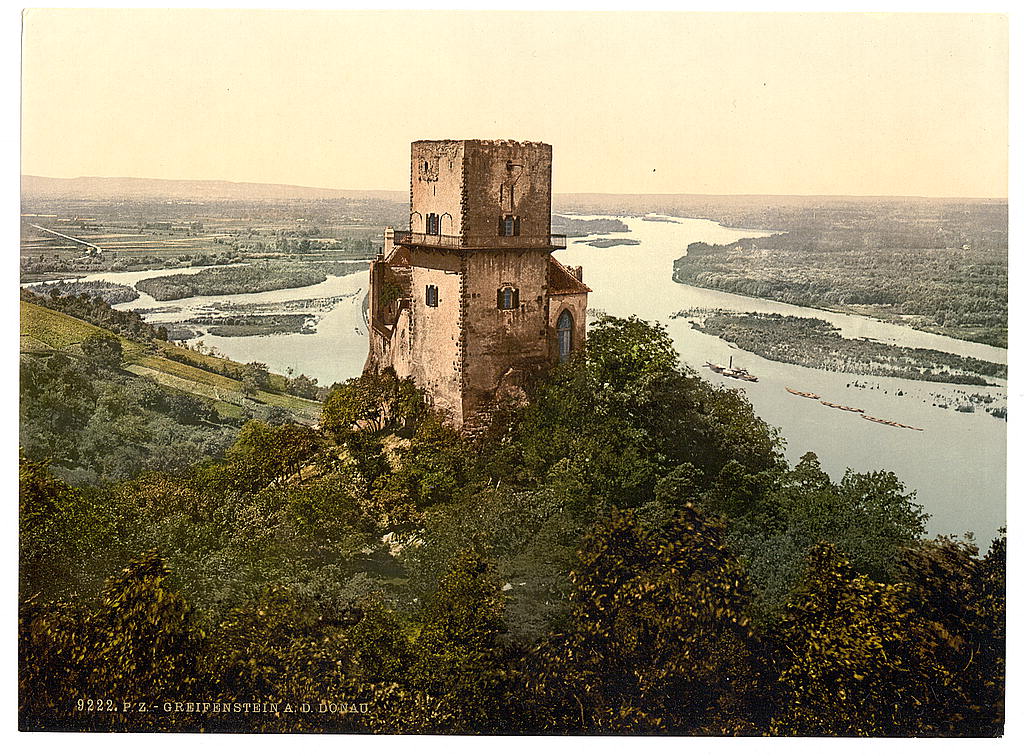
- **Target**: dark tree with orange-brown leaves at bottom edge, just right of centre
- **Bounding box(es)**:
[529,507,761,734]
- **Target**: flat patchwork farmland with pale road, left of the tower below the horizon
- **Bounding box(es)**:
[20,192,408,283]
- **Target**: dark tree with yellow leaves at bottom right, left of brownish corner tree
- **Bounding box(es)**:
[771,544,970,737]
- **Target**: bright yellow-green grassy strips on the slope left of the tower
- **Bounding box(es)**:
[22,302,319,418]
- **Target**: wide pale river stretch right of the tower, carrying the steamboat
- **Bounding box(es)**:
[556,216,1007,550]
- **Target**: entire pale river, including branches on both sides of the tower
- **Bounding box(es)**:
[75,216,1007,550]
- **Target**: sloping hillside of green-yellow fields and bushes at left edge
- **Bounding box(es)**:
[20,293,319,481]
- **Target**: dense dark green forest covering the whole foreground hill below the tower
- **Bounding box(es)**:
[19,318,1006,736]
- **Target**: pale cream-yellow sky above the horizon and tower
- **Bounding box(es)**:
[22,9,1009,197]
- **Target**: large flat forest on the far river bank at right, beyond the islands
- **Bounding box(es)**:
[673,229,1009,346]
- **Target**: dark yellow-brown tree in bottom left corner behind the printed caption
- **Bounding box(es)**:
[19,553,204,730]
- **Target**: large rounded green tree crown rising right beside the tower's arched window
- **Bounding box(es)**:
[510,317,781,508]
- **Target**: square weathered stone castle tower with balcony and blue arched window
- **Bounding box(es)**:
[364,139,590,427]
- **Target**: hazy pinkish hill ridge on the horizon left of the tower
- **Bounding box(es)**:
[22,176,409,202]
